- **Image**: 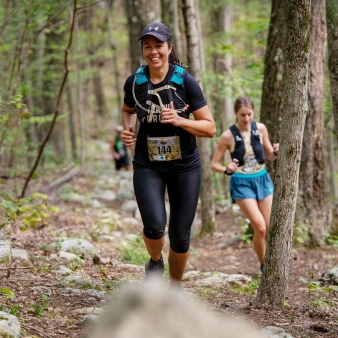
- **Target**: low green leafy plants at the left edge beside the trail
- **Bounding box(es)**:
[0,193,59,230]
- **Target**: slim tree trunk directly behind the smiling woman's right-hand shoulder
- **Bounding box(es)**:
[182,0,216,237]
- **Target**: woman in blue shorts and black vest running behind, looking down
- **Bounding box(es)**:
[211,97,279,271]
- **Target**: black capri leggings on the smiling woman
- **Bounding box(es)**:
[133,167,201,253]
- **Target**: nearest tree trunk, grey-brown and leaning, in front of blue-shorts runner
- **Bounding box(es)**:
[255,0,311,307]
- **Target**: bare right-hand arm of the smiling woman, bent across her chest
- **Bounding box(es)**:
[161,102,216,138]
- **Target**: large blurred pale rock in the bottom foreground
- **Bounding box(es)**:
[90,279,260,338]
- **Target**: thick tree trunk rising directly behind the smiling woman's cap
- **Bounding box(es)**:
[124,0,161,73]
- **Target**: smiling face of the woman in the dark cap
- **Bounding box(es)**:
[142,35,171,68]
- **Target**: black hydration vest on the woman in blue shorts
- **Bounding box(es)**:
[230,121,265,166]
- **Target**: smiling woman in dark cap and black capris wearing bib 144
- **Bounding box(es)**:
[122,23,215,283]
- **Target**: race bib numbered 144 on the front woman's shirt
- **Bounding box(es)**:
[147,136,182,161]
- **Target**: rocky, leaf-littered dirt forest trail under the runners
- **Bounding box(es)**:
[0,141,338,338]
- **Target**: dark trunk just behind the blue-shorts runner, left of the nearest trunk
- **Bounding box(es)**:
[260,0,286,179]
